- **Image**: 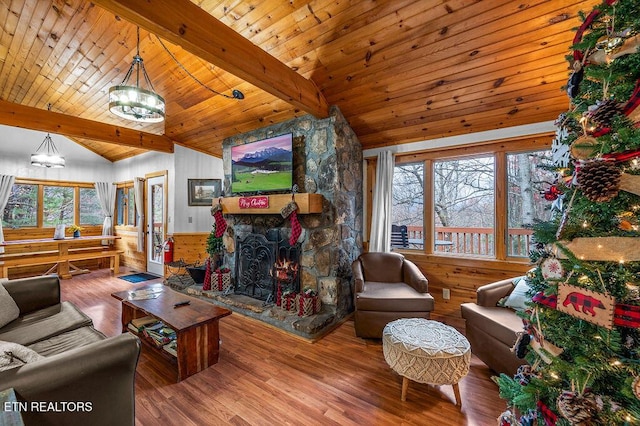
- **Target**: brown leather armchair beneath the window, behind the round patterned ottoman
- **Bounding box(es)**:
[351,253,433,338]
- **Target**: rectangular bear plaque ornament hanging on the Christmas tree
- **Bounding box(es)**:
[556,284,616,329]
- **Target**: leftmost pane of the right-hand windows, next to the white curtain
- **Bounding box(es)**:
[391,163,424,249]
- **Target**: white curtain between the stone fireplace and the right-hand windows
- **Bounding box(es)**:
[369,151,394,252]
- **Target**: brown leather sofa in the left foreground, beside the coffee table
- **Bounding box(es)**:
[0,275,140,425]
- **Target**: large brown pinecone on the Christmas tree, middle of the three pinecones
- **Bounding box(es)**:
[577,160,621,202]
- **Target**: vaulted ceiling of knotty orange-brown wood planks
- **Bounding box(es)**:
[0,0,599,161]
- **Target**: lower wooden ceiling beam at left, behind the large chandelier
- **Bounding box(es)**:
[0,100,173,153]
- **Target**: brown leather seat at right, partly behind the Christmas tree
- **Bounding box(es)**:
[460,278,526,376]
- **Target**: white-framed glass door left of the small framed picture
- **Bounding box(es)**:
[147,176,166,276]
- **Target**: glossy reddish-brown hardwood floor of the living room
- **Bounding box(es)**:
[62,268,505,426]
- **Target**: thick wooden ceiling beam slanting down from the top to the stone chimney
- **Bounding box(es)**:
[94,0,329,118]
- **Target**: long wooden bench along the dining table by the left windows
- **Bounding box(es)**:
[0,247,124,279]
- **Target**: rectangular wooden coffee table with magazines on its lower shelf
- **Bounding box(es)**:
[111,284,231,381]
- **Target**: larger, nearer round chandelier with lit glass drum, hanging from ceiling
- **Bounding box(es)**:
[109,27,165,123]
